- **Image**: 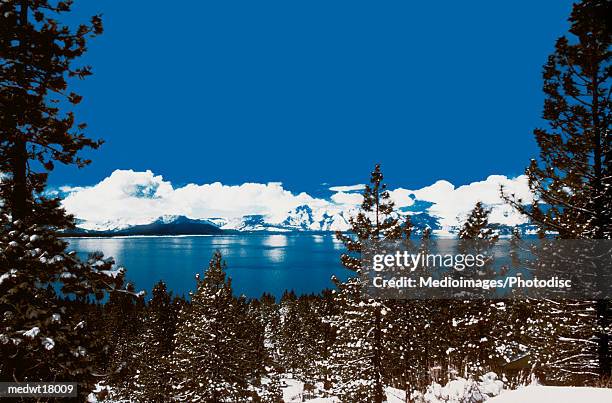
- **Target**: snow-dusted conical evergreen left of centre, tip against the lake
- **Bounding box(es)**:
[170,252,251,402]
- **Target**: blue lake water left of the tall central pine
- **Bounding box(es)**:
[68,234,350,297]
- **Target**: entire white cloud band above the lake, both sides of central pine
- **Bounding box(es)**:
[61,170,531,232]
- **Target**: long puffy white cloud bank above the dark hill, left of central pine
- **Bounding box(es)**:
[62,170,329,228]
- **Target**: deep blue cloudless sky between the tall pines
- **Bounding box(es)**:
[51,0,571,194]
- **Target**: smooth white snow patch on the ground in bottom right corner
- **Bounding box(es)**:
[487,385,612,403]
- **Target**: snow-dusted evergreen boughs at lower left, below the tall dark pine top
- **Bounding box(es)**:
[0,232,123,393]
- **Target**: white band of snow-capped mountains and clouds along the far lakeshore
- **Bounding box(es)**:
[62,170,532,236]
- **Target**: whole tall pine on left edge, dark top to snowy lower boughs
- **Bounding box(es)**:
[0,0,129,394]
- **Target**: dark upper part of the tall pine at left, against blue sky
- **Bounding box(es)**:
[0,0,102,228]
